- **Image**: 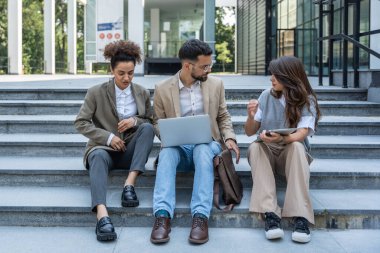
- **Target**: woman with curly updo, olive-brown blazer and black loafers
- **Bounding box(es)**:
[74,40,154,241]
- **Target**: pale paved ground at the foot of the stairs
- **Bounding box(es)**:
[0,227,380,253]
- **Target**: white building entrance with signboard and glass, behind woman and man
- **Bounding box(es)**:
[85,0,218,74]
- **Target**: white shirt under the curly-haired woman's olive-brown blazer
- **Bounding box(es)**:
[107,84,137,146]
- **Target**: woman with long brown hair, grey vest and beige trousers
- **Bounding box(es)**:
[245,56,321,243]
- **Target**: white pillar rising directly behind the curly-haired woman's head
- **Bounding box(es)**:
[128,0,144,75]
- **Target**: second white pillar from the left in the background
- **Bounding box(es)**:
[44,0,55,74]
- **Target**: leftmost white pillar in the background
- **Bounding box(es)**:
[8,0,23,75]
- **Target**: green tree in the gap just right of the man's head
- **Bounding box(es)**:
[215,7,235,71]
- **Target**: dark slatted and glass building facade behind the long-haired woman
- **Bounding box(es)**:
[236,0,380,75]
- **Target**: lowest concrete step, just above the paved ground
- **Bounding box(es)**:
[0,186,380,229]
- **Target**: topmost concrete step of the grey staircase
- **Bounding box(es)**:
[0,85,367,101]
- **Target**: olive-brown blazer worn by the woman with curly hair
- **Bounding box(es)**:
[74,79,153,168]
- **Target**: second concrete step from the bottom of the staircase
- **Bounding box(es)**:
[0,156,380,189]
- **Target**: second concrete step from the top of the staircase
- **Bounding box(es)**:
[0,100,380,116]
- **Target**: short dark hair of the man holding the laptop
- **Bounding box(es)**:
[178,39,212,61]
